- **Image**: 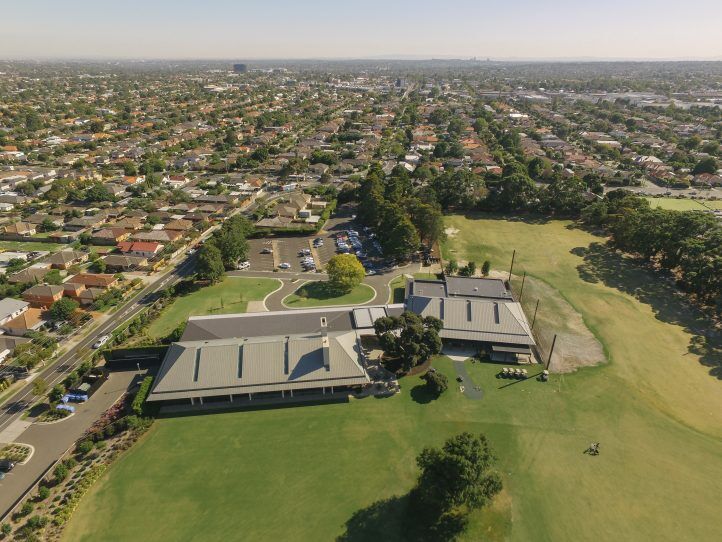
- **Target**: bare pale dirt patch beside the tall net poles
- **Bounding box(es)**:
[512,276,606,373]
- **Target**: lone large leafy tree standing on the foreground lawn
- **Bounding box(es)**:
[415,433,502,516]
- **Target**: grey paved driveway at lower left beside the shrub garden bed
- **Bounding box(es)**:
[0,371,140,517]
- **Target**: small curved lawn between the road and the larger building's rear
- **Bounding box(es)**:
[148,277,278,338]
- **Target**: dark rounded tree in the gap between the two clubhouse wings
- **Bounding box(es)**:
[374,311,443,372]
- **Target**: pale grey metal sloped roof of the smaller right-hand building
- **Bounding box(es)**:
[407,296,534,345]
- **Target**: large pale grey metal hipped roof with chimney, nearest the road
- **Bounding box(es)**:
[149,331,369,401]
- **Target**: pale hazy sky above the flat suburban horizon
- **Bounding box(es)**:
[5,0,722,60]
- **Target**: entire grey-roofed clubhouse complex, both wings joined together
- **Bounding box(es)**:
[148,277,534,407]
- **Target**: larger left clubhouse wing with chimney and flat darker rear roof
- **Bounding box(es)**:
[148,305,404,405]
